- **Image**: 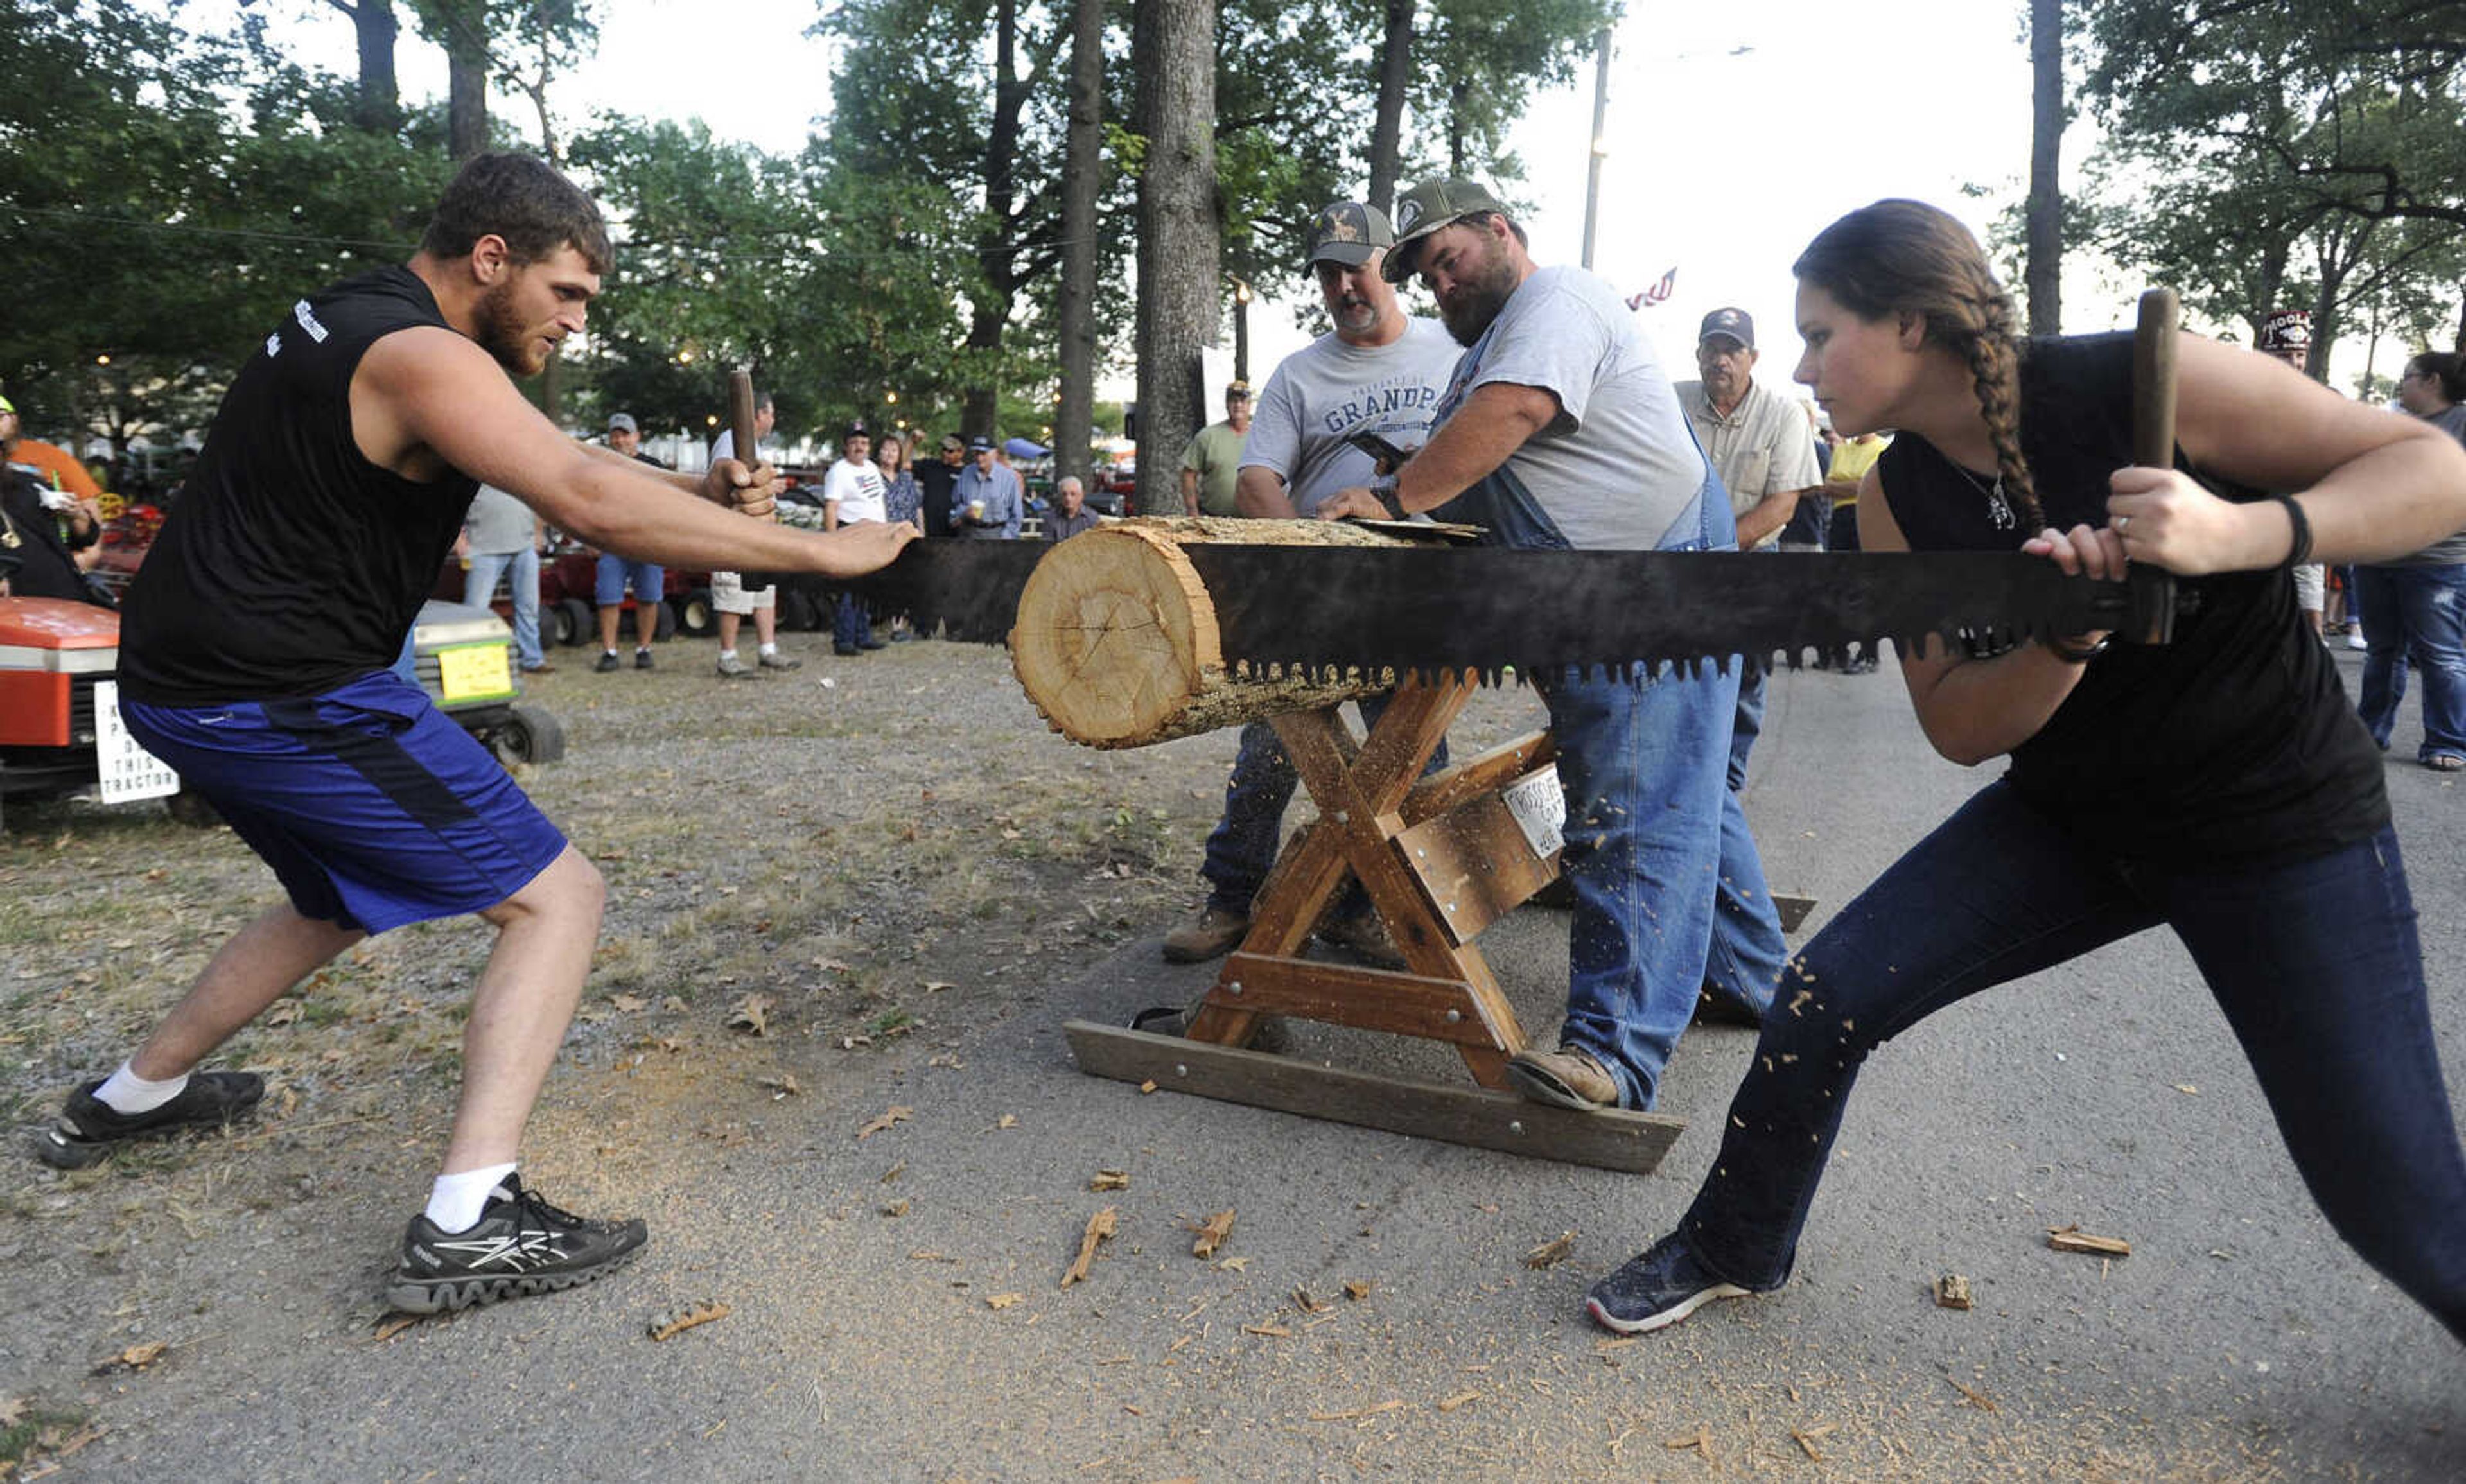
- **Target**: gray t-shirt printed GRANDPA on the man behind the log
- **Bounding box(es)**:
[1241,318,1462,518]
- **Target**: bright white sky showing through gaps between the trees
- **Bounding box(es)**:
[188,0,2360,394]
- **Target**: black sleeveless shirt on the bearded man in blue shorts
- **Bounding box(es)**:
[121,266,478,705]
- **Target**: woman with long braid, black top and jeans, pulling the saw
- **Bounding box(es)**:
[1586,202,2466,1339]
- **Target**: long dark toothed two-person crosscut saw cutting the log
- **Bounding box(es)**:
[843,288,2178,681]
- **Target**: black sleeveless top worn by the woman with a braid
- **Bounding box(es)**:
[1876,335,2390,865]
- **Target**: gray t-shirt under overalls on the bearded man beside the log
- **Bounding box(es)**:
[1440,266,1704,550]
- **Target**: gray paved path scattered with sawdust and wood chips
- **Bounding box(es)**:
[19,663,2466,1479]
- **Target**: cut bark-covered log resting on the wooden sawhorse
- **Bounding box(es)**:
[1011,515,1413,747]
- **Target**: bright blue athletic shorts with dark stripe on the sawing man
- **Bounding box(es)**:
[121,670,564,932]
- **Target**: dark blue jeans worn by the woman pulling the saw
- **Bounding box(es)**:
[1679,784,2466,1341]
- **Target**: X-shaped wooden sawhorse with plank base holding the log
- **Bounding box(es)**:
[1068,678,1687,1173]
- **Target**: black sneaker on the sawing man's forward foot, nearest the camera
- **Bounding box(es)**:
[385,1176,651,1314]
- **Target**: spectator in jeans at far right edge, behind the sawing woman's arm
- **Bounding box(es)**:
[2355,353,2466,774]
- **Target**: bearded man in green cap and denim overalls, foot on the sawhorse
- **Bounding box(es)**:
[1319,180,1783,1109]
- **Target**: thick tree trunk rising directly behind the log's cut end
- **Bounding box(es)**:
[1132,0,1218,512]
